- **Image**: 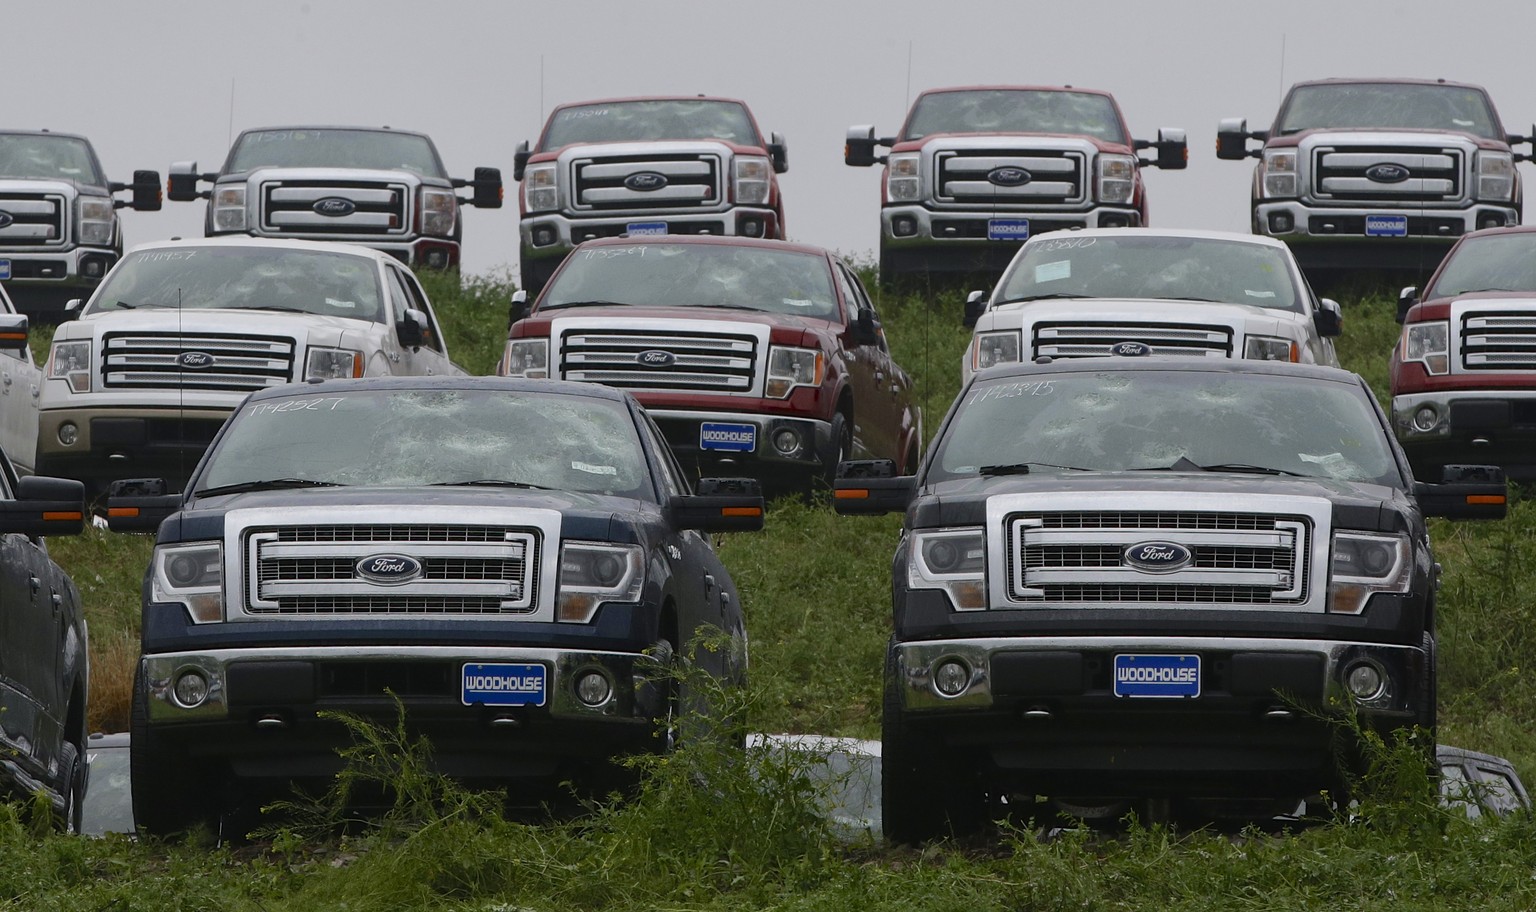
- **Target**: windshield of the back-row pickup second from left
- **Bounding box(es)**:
[224,129,447,180]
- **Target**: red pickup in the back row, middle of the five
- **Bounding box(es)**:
[513,95,790,296]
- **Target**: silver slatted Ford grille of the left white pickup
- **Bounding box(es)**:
[101,333,295,390]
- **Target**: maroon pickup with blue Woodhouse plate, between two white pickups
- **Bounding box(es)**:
[498,236,922,490]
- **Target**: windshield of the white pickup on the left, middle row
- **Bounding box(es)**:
[86,244,384,322]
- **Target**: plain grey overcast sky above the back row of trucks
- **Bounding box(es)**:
[12,0,1536,273]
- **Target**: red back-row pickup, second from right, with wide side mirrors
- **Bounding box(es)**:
[843,86,1189,283]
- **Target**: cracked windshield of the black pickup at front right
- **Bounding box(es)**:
[926,370,1404,487]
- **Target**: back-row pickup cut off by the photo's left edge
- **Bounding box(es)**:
[0,131,160,319]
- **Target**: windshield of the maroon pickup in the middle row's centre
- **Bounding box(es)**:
[539,244,839,319]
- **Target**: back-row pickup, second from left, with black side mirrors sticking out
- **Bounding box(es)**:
[166,126,502,269]
